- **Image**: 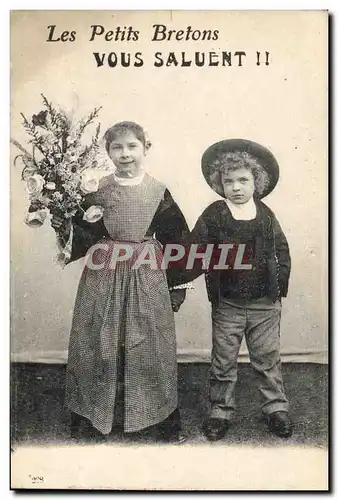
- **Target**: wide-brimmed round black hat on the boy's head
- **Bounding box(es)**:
[202,139,279,198]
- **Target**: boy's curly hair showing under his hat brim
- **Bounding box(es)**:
[210,151,270,195]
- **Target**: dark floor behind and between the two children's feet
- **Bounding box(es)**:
[11,363,328,449]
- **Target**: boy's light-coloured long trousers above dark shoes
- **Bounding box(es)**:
[210,297,288,420]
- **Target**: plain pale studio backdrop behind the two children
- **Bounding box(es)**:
[11,11,328,362]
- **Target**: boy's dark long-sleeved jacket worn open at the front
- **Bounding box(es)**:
[181,200,291,305]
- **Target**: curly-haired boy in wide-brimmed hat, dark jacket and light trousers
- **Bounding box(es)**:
[188,139,292,441]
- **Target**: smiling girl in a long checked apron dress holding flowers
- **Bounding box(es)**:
[52,122,189,441]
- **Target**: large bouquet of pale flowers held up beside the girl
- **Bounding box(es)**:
[11,94,108,227]
